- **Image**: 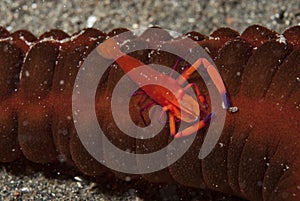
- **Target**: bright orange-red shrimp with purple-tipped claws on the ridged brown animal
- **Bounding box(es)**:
[97,38,230,138]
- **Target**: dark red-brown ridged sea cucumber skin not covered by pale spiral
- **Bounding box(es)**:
[0,25,300,201]
